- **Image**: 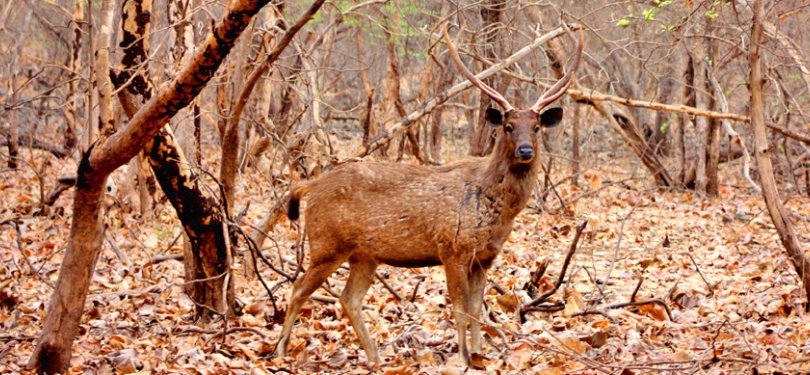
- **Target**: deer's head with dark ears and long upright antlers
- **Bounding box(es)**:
[444,24,584,168]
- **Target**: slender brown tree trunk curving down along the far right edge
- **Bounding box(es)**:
[748,0,810,309]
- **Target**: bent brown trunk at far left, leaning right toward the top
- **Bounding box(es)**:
[29,0,267,374]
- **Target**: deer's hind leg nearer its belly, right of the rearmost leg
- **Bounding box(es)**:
[340,259,380,363]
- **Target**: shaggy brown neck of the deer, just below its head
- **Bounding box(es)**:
[480,141,540,222]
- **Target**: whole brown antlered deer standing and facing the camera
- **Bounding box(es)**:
[275,25,583,366]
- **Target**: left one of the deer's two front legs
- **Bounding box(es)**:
[445,262,472,366]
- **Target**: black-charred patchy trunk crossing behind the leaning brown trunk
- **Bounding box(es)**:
[116,0,234,320]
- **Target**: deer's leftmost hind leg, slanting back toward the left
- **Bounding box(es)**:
[275,256,343,357]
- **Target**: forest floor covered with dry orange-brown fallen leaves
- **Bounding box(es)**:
[0,133,810,374]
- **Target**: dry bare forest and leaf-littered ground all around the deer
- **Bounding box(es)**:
[0,0,810,373]
